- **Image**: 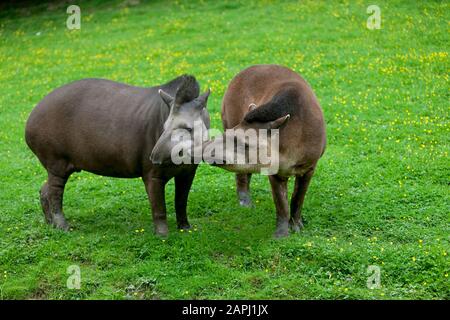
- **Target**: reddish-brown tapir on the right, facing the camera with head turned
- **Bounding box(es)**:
[203,65,326,237]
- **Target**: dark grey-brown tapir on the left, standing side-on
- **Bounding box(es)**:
[25,75,210,236]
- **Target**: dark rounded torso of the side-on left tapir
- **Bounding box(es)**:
[25,79,169,177]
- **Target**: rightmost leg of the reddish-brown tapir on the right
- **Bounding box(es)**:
[289,170,314,232]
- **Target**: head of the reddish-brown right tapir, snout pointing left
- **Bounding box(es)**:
[203,104,290,174]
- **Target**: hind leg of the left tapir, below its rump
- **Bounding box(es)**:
[40,172,69,230]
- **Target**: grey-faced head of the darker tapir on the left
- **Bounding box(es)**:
[150,77,210,164]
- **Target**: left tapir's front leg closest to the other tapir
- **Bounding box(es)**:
[175,170,195,229]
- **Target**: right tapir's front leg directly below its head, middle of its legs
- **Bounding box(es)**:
[269,175,289,238]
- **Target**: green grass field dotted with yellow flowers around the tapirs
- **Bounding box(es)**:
[0,0,450,299]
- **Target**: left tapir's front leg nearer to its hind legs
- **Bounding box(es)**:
[144,177,169,237]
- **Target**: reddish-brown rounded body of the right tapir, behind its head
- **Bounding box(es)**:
[222,65,326,172]
